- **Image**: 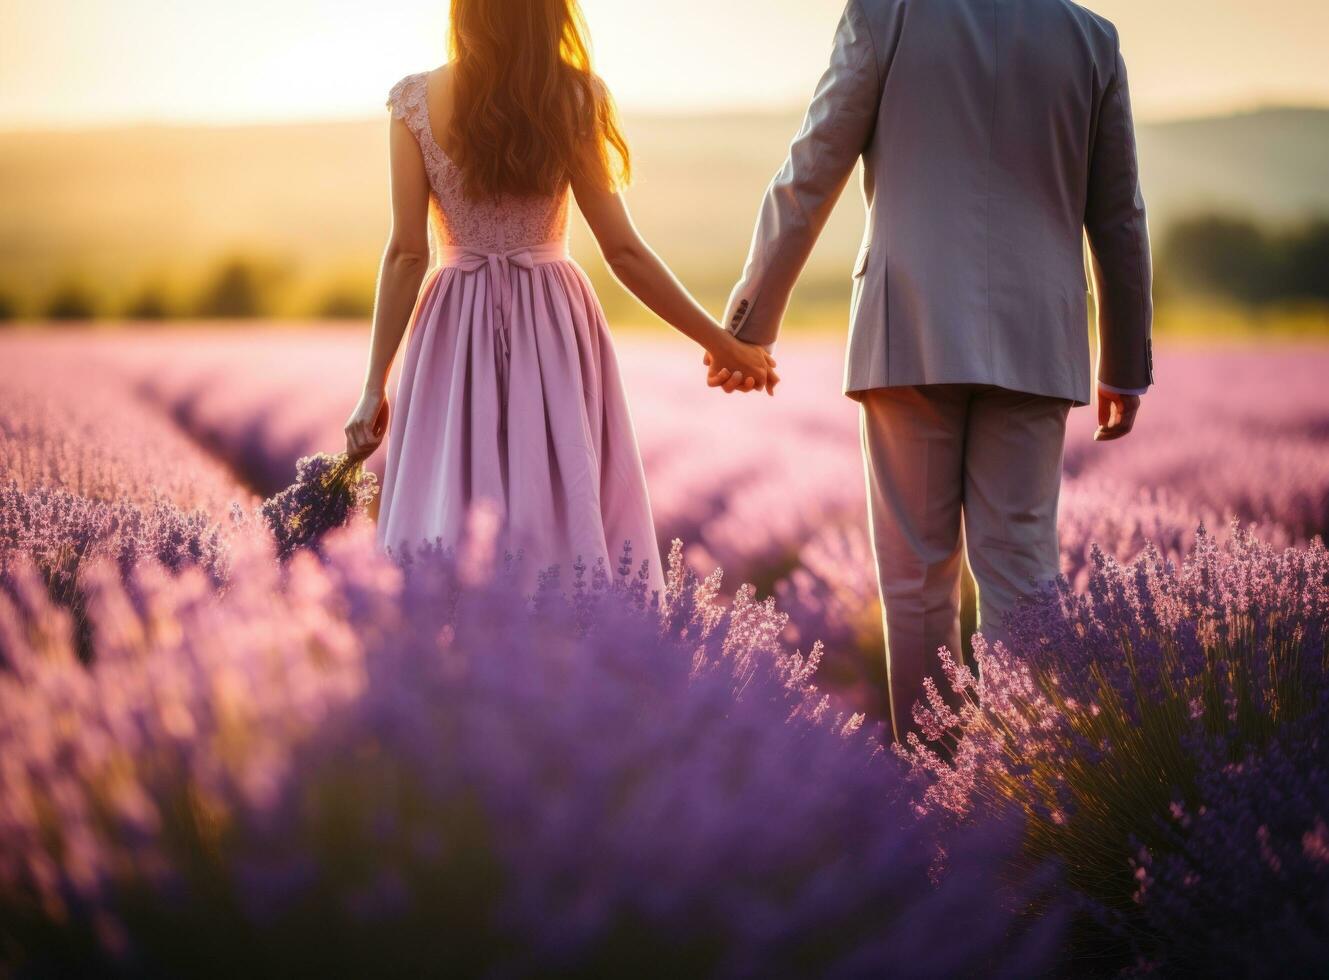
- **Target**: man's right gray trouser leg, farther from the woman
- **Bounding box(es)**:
[965,388,1071,642]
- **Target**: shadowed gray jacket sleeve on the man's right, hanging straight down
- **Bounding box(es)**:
[1084,41,1154,391]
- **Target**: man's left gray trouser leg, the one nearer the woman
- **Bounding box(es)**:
[863,384,970,739]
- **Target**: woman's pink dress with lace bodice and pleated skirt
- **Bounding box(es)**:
[377,72,663,590]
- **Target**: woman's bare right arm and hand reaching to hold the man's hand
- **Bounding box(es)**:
[573,156,780,394]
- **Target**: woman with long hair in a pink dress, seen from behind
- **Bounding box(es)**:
[346,0,779,589]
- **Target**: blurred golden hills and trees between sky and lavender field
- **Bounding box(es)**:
[0,109,1329,328]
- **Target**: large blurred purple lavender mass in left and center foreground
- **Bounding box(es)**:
[0,515,1059,976]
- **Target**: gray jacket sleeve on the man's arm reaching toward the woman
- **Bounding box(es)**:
[724,0,881,344]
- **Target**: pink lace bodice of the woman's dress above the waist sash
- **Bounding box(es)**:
[387,72,567,251]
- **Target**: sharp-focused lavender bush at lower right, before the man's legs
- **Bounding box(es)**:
[901,529,1329,969]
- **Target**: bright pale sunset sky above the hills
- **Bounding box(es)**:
[0,0,1329,129]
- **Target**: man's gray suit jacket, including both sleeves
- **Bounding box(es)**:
[726,0,1154,404]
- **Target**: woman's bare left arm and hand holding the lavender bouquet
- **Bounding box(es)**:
[346,116,429,459]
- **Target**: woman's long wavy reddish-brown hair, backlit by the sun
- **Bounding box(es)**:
[448,0,631,198]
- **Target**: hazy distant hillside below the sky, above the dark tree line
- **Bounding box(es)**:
[0,109,1329,315]
